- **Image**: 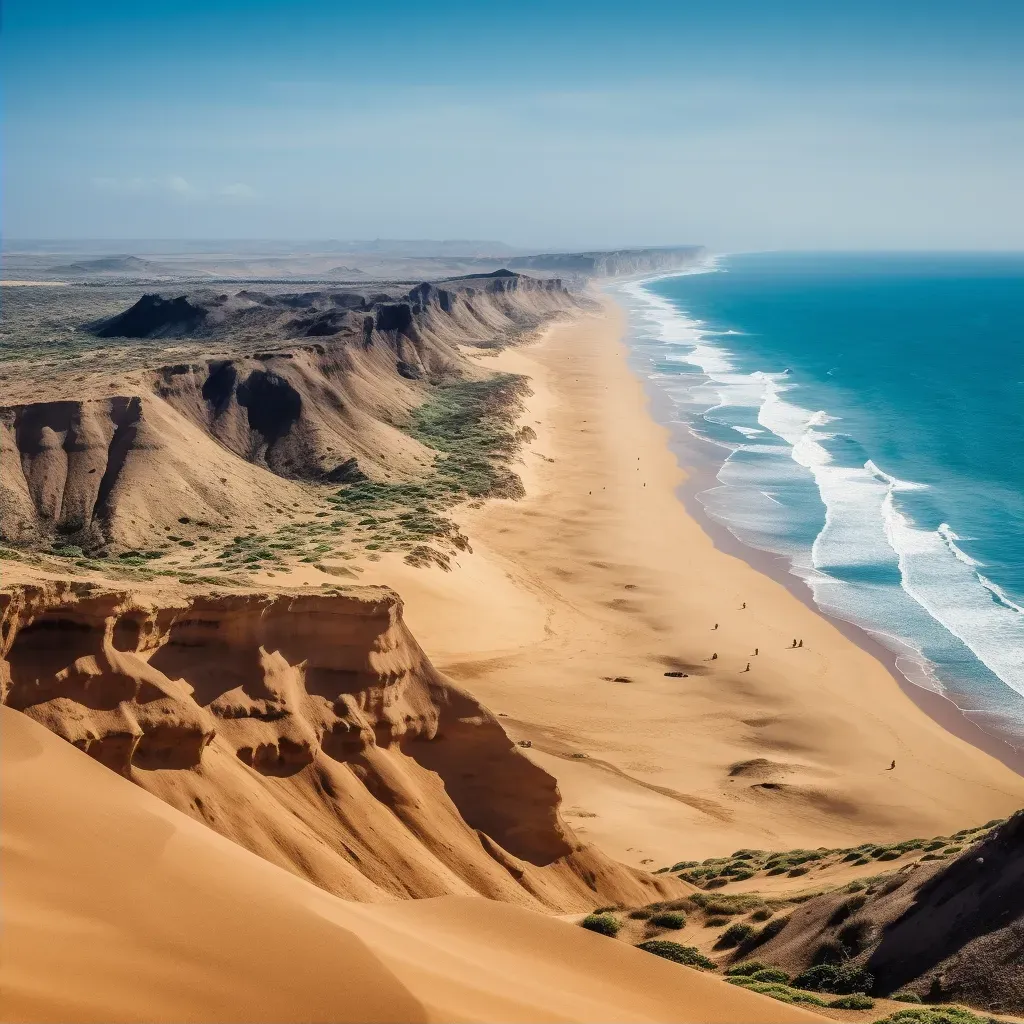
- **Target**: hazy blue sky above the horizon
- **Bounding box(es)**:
[0,0,1024,251]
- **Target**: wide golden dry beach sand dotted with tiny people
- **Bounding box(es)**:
[358,299,1024,867]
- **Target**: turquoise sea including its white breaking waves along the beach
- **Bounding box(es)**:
[618,247,1024,746]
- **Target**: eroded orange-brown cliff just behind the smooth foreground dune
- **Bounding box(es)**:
[0,584,679,910]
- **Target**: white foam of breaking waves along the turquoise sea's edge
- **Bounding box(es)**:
[625,268,1024,712]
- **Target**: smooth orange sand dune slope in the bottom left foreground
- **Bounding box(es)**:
[0,708,817,1024]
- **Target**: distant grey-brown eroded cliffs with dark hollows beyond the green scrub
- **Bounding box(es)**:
[0,271,577,549]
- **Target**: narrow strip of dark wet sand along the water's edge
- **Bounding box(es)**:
[604,278,1024,776]
